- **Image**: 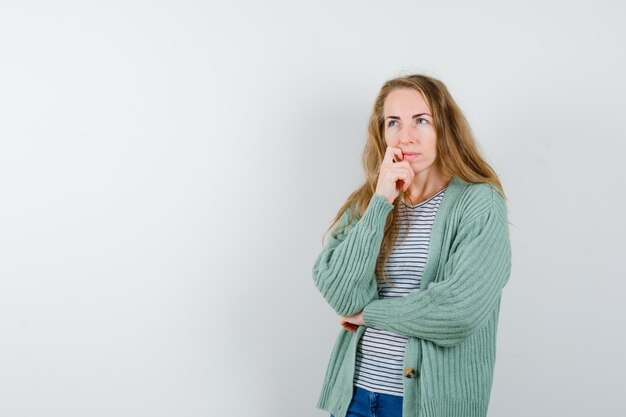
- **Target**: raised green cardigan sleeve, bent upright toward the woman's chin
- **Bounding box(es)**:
[313,194,393,315]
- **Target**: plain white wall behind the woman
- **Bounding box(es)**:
[0,0,626,417]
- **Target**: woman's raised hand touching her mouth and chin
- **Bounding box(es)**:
[375,146,415,204]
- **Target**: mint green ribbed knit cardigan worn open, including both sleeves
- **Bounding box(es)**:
[313,176,511,417]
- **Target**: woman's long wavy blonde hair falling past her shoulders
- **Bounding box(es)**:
[322,74,506,282]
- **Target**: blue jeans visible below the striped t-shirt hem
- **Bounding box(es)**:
[331,386,402,417]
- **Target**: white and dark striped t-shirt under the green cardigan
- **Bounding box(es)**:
[354,188,447,395]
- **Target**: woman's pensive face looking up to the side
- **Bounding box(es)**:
[383,88,437,174]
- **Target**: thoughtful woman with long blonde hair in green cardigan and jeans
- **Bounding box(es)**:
[313,75,511,417]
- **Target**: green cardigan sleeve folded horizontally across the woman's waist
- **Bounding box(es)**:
[363,187,511,346]
